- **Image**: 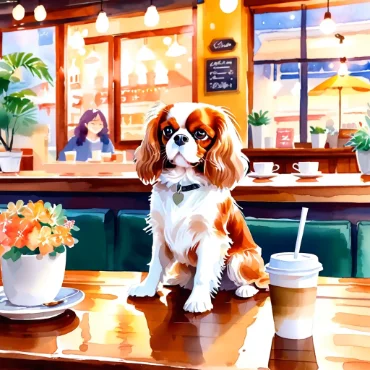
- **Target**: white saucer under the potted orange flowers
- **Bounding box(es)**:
[0,287,85,320]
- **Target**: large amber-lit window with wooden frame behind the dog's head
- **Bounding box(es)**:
[66,9,195,152]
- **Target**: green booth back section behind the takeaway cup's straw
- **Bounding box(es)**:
[246,217,353,277]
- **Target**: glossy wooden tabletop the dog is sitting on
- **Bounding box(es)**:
[0,272,370,370]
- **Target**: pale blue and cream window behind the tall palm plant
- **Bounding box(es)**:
[2,27,56,160]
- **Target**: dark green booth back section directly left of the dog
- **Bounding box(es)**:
[114,210,153,272]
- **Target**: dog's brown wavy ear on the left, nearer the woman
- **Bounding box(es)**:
[134,103,172,184]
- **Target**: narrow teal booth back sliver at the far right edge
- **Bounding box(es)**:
[355,221,370,278]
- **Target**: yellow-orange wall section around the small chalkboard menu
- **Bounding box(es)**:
[196,0,250,146]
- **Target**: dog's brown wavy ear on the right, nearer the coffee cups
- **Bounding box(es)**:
[204,109,248,189]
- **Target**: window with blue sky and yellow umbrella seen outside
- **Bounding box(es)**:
[253,4,370,142]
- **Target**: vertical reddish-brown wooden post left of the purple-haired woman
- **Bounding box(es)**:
[55,25,68,157]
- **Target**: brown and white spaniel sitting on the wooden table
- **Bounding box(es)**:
[129,103,268,312]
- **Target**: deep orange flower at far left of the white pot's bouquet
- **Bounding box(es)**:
[2,216,35,248]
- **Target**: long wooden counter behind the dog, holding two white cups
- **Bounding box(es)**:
[0,171,370,203]
